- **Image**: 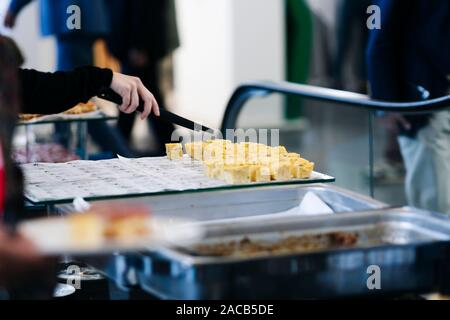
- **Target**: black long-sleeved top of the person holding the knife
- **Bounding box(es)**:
[0,55,113,225]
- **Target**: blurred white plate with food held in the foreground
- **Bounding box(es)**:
[18,217,204,255]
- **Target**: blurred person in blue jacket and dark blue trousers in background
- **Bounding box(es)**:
[4,0,133,157]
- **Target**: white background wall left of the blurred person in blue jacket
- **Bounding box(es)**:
[0,0,56,71]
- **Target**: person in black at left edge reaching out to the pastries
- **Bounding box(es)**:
[0,35,159,299]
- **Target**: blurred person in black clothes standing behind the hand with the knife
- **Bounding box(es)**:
[107,0,179,156]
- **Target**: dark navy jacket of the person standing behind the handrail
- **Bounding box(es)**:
[367,0,450,136]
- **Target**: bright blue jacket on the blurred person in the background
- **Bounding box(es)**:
[9,0,110,36]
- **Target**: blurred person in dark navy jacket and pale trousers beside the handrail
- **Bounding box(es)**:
[367,0,450,214]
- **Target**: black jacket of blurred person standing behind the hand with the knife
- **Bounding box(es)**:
[107,0,179,62]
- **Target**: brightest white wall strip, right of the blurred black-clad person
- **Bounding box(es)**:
[174,0,232,130]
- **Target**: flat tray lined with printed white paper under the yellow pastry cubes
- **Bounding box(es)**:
[22,157,334,205]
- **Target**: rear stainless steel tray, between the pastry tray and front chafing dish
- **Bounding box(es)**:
[68,184,387,294]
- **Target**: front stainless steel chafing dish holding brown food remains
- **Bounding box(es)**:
[138,208,450,299]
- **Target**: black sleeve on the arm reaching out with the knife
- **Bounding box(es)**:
[19,67,113,114]
